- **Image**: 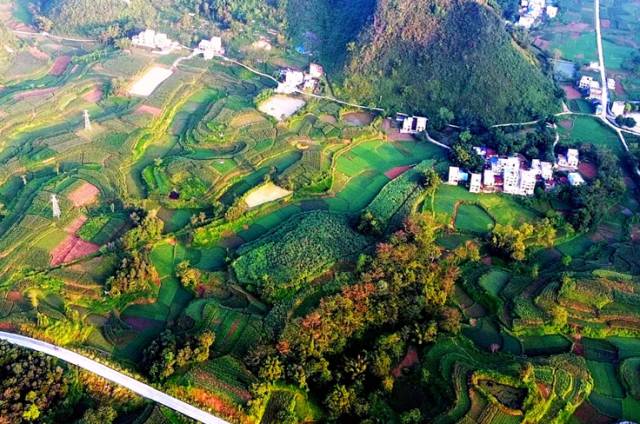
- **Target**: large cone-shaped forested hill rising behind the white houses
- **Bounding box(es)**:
[346,0,559,125]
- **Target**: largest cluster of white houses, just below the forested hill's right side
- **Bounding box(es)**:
[447,147,585,196]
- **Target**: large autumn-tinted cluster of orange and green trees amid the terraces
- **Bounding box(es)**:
[250,215,478,421]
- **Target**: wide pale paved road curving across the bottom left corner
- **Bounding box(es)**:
[0,331,228,424]
